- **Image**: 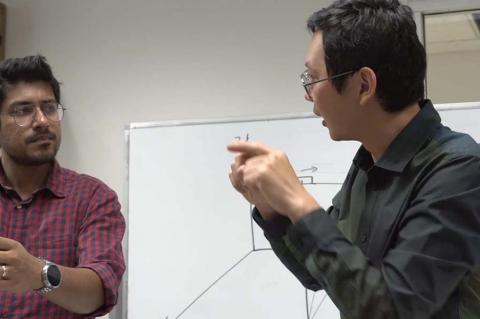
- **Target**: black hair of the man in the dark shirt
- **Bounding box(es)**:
[307,0,427,112]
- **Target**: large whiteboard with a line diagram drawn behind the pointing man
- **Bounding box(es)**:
[123,103,480,319]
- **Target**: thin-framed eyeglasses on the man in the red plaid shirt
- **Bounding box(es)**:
[9,102,66,126]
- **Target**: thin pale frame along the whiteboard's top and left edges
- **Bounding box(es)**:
[116,101,480,319]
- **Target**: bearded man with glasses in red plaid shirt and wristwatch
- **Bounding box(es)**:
[0,56,125,318]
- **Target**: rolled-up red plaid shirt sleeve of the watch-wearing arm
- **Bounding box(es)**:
[77,184,125,316]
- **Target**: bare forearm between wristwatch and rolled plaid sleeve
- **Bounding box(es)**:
[45,266,104,314]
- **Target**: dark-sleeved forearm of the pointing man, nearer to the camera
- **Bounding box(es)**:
[284,210,397,319]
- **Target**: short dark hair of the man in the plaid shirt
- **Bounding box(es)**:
[0,55,60,105]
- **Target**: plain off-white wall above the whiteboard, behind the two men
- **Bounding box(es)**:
[3,0,480,318]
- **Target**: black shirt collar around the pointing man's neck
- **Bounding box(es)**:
[353,100,441,173]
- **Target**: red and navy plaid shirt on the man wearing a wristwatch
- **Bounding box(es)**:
[0,162,125,319]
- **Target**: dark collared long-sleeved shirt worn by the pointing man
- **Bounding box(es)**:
[253,100,480,319]
